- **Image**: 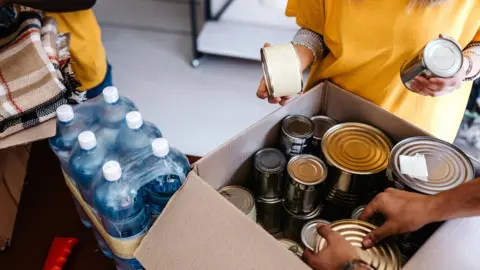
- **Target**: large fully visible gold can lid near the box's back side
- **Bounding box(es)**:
[322,123,392,174]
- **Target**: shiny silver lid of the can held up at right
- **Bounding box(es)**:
[423,38,463,78]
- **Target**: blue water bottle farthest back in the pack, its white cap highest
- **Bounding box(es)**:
[95,86,137,149]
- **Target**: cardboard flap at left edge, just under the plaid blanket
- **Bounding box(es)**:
[0,118,56,149]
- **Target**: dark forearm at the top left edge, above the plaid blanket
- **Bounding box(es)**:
[8,0,96,12]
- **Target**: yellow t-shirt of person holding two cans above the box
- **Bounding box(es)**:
[286,0,480,142]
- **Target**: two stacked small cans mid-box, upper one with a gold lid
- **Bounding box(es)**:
[283,154,328,242]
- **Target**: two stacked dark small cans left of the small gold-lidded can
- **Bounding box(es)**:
[254,148,287,234]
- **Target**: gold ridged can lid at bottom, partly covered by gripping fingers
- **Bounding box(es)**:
[315,219,402,270]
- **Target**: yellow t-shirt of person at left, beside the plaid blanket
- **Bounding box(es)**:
[46,10,107,90]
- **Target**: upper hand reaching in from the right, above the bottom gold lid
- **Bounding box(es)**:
[360,188,433,248]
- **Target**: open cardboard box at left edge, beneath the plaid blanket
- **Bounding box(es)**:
[0,120,55,251]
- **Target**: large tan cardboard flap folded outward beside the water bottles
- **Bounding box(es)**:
[135,172,309,270]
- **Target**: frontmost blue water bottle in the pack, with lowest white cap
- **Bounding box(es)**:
[94,161,149,269]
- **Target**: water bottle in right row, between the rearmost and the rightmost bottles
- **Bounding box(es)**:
[117,111,162,155]
